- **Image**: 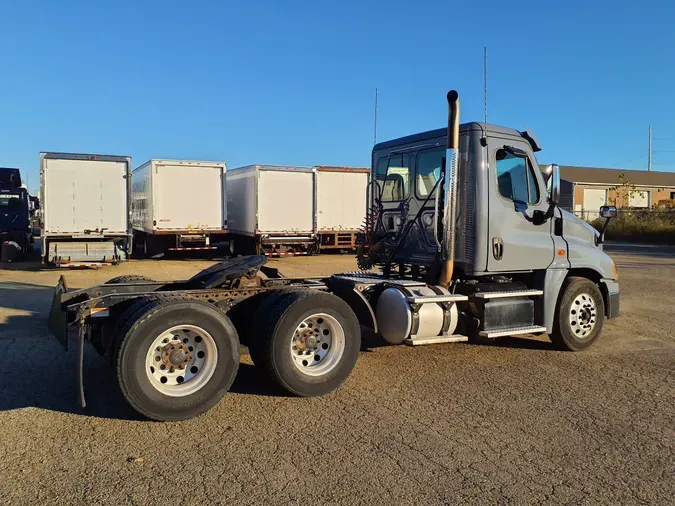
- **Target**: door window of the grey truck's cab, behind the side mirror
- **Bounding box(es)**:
[496,149,539,204]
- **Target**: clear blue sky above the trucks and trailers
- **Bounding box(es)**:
[0,0,675,189]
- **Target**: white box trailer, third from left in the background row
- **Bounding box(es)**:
[227,165,317,256]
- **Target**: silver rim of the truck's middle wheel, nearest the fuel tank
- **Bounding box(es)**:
[290,313,345,376]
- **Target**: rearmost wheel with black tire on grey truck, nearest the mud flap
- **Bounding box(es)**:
[117,296,239,421]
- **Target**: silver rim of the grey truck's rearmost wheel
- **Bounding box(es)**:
[145,325,218,397]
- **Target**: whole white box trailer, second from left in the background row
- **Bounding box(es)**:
[131,160,227,257]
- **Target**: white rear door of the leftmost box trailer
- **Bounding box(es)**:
[42,158,128,234]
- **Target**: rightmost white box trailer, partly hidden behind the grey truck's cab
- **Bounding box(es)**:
[316,165,370,250]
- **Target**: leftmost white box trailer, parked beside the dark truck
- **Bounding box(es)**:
[40,153,131,267]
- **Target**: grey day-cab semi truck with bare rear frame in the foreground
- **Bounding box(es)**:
[49,91,619,420]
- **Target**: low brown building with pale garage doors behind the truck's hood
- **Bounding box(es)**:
[548,165,675,218]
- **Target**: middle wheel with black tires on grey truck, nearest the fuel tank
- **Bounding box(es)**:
[249,290,361,397]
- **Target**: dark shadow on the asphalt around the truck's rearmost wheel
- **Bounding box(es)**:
[0,282,285,420]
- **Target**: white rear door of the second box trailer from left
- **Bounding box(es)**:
[154,163,223,231]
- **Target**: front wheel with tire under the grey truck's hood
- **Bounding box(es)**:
[550,277,605,351]
